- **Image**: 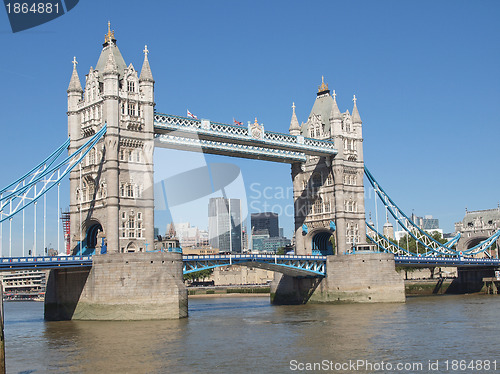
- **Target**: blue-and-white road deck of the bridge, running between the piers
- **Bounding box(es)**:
[0,254,500,277]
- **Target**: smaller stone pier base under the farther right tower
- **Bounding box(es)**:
[271,253,405,305]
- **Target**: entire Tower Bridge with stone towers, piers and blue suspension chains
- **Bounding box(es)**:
[0,24,500,319]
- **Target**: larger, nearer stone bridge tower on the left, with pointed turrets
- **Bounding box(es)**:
[68,23,155,253]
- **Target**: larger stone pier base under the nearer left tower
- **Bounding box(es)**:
[45,253,188,321]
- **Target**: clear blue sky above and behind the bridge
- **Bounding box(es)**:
[0,0,500,254]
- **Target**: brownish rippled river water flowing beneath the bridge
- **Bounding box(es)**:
[4,295,500,373]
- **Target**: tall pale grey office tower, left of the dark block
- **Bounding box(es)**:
[208,197,242,253]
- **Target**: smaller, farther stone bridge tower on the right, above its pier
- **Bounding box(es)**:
[290,80,367,254]
